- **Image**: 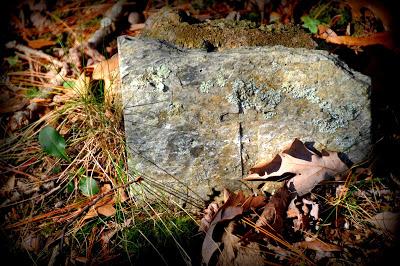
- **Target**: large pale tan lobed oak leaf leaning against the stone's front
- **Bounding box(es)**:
[244,139,348,196]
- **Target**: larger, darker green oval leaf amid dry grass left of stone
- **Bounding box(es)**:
[39,126,71,162]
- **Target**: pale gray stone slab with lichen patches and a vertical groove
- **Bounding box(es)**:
[118,36,371,199]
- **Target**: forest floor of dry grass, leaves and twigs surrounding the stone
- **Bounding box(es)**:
[0,0,400,265]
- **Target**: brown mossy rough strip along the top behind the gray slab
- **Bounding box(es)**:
[141,8,315,49]
